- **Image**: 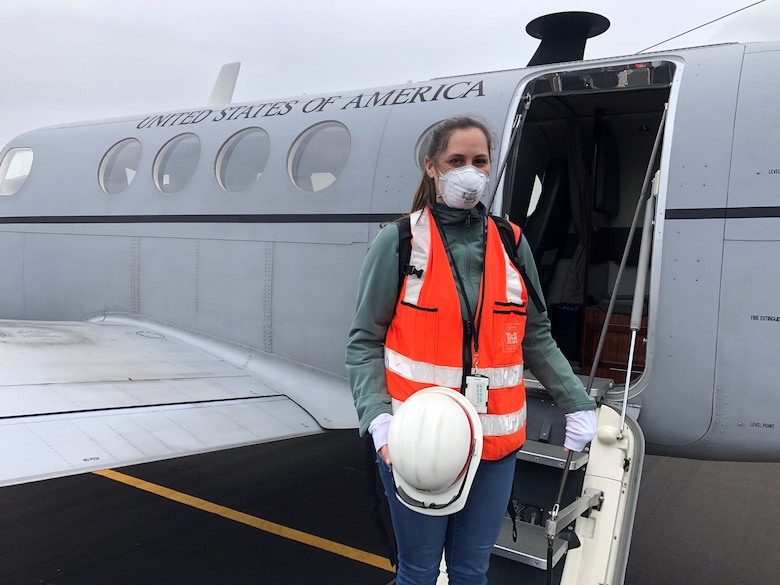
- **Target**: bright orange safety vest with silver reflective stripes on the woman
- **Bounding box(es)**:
[385,207,528,460]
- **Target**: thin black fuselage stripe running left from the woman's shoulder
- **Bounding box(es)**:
[0,213,400,224]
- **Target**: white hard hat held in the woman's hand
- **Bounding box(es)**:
[387,386,482,516]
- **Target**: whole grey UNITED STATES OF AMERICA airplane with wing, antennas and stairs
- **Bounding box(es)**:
[0,13,780,585]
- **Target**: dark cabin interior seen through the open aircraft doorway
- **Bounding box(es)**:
[504,62,673,384]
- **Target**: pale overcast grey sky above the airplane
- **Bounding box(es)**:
[0,0,780,146]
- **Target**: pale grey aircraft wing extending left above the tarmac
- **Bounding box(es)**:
[0,316,357,486]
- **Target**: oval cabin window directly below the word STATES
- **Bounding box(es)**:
[215,128,271,193]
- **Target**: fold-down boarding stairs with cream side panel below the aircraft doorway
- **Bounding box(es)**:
[489,377,644,585]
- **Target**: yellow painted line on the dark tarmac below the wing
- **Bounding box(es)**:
[93,469,395,573]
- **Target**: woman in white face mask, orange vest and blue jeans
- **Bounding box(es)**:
[346,116,595,585]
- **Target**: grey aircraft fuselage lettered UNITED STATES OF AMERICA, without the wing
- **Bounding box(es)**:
[0,43,780,461]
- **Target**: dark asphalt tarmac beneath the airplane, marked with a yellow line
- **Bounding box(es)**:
[0,431,780,585]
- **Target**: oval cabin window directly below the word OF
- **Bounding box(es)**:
[287,122,351,193]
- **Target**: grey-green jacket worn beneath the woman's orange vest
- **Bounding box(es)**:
[346,204,596,435]
